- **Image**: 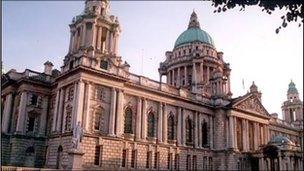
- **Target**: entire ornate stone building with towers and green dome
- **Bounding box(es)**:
[1,0,303,170]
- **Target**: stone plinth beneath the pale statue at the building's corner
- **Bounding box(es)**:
[68,149,84,170]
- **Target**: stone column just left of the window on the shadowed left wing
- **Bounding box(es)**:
[16,91,27,133]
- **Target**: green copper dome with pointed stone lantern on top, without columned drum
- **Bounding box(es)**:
[174,11,215,48]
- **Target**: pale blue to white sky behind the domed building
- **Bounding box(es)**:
[2,1,303,117]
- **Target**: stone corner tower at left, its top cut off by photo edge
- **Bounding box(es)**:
[61,0,125,73]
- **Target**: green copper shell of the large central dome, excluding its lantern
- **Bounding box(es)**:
[174,28,215,48]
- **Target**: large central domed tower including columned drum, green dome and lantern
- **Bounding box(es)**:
[159,11,231,97]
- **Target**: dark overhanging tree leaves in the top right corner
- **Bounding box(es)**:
[212,0,303,33]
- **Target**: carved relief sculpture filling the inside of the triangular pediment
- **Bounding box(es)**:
[235,97,267,115]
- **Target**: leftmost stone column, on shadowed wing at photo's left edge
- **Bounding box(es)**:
[2,93,13,133]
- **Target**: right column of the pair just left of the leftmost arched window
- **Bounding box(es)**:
[116,90,124,136]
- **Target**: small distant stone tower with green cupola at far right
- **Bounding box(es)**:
[282,81,303,124]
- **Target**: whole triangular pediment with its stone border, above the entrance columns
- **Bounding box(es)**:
[232,94,269,116]
